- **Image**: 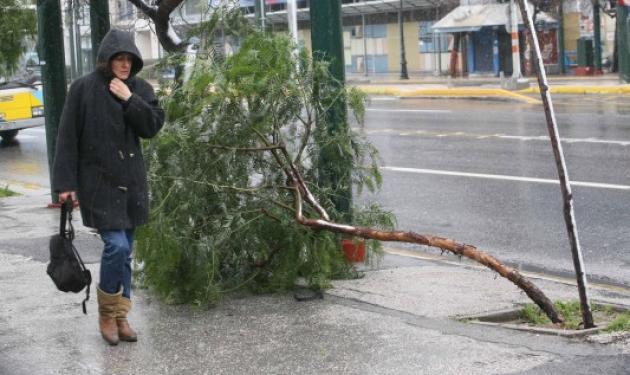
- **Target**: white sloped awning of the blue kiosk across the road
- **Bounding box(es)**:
[432,4,557,33]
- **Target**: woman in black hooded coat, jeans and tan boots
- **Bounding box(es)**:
[53,30,164,345]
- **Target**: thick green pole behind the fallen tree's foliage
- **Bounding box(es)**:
[310,0,352,220]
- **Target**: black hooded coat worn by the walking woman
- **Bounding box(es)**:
[52,29,164,230]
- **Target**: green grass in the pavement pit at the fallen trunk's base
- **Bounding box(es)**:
[521,301,630,332]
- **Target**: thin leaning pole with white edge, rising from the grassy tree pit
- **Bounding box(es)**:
[518,0,595,328]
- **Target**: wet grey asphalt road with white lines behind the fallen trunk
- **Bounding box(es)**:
[364,96,630,285]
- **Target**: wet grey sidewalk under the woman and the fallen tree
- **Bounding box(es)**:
[0,190,630,375]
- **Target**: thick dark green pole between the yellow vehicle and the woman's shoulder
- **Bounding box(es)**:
[37,0,66,204]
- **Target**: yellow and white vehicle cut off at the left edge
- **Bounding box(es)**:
[0,84,44,142]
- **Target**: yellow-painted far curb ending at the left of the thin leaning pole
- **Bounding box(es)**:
[357,86,540,104]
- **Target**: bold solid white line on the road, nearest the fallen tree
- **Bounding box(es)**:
[382,167,630,190]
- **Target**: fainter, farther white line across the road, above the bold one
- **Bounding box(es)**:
[355,128,630,146]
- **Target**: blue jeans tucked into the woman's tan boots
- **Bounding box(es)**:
[99,229,133,298]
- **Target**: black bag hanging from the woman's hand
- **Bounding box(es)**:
[46,199,92,314]
